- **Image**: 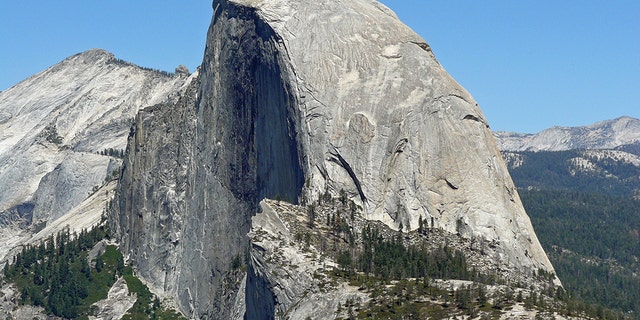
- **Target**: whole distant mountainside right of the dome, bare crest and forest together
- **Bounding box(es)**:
[494,117,640,319]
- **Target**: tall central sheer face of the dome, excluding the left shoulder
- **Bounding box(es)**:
[182,3,304,317]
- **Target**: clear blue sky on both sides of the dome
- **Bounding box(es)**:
[0,0,640,133]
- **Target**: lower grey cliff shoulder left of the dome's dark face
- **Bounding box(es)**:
[110,78,196,312]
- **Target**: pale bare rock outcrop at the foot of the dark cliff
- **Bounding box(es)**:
[244,200,370,319]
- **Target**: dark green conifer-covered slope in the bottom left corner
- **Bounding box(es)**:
[1,221,185,320]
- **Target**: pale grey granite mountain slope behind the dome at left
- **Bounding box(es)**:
[0,49,189,260]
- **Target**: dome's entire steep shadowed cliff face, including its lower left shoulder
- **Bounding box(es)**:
[115,2,304,318]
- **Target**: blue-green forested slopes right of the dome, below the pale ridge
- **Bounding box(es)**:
[505,148,640,318]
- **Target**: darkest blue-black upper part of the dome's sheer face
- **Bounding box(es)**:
[196,3,304,204]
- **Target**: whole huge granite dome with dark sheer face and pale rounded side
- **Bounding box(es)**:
[112,0,553,318]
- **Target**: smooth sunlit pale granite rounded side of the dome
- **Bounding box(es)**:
[221,0,553,280]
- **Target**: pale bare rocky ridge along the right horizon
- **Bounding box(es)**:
[493,116,640,153]
